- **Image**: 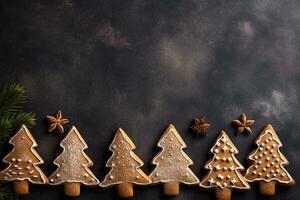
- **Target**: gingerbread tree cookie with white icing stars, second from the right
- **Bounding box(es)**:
[200,131,250,200]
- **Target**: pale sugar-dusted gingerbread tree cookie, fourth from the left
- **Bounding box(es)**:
[149,124,199,196]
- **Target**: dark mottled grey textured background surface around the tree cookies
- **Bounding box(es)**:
[0,0,300,200]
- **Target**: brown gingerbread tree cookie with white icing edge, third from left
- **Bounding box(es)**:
[100,128,151,198]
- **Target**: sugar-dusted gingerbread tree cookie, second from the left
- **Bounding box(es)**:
[49,126,99,196]
